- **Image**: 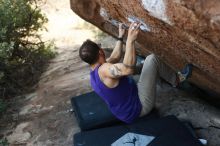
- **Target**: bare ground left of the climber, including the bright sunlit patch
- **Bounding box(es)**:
[0,0,113,146]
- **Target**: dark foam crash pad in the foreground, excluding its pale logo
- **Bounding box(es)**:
[73,116,202,146]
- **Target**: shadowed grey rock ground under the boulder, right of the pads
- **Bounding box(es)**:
[156,83,220,146]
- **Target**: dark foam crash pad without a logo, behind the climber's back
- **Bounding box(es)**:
[71,91,119,130]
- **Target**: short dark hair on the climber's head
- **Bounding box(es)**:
[79,40,100,65]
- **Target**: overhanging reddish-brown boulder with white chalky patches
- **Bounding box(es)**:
[71,0,220,93]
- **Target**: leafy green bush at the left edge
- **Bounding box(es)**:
[0,0,54,98]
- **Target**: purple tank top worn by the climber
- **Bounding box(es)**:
[90,66,142,123]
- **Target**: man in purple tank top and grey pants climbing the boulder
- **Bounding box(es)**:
[79,23,191,123]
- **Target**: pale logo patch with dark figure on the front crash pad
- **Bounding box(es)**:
[111,133,155,146]
